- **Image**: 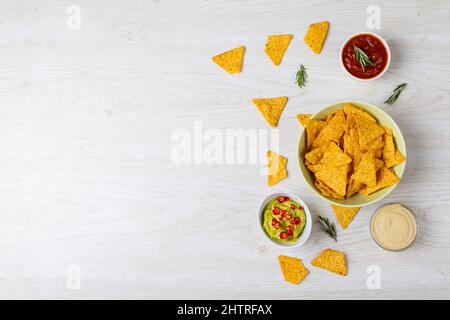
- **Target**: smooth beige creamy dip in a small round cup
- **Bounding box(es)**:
[370,203,417,251]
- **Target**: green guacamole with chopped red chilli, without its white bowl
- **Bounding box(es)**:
[263,196,306,243]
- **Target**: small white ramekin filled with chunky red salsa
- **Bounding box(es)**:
[340,32,391,81]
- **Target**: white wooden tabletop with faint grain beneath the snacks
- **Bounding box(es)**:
[0,0,450,299]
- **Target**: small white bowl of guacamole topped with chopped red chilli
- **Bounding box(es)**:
[258,192,312,247]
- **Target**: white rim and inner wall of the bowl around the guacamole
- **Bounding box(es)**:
[258,191,312,248]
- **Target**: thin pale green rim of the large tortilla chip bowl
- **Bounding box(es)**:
[297,100,408,208]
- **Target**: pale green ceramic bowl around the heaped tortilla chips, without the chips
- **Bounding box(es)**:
[298,101,406,207]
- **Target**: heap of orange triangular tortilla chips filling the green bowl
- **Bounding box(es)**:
[299,104,405,199]
